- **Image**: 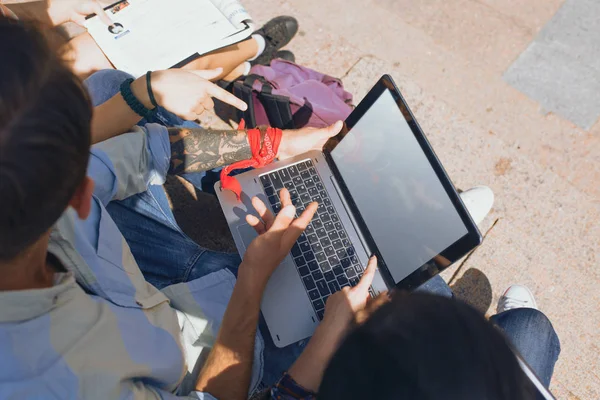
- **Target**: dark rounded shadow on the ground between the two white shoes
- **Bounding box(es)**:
[450,268,492,314]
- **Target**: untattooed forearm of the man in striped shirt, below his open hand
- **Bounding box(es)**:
[196,280,262,400]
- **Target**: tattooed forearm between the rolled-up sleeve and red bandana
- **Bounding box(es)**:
[169,128,252,175]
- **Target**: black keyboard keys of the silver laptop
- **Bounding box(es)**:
[260,160,373,320]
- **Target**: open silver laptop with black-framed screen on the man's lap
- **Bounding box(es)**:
[215,75,482,347]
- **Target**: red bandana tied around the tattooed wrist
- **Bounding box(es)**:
[221,120,282,201]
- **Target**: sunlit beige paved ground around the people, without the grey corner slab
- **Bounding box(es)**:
[170,0,600,399]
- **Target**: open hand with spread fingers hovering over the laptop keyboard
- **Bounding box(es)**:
[238,188,318,290]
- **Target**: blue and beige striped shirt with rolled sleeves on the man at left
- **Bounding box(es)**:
[0,125,263,400]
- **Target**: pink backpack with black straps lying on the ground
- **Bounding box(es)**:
[233,59,352,129]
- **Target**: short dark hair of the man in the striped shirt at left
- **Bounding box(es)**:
[0,17,92,260]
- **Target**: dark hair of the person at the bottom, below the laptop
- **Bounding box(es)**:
[318,294,533,400]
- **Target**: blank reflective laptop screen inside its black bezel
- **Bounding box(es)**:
[331,90,468,283]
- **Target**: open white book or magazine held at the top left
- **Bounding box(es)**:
[86,0,253,77]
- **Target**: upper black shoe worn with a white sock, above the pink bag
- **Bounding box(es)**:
[250,16,298,65]
